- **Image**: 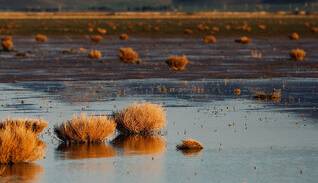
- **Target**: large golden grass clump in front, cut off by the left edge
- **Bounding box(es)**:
[0,125,46,164]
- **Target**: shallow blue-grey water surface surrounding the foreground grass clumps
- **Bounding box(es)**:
[0,78,318,183]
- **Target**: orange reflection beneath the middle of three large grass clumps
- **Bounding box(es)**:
[56,144,116,160]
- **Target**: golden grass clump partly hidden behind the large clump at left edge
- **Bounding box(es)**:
[0,118,48,134]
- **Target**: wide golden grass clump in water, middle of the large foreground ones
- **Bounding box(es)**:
[54,113,116,144]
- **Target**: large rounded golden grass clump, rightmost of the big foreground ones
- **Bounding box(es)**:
[114,102,166,134]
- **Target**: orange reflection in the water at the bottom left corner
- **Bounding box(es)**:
[0,163,44,182]
